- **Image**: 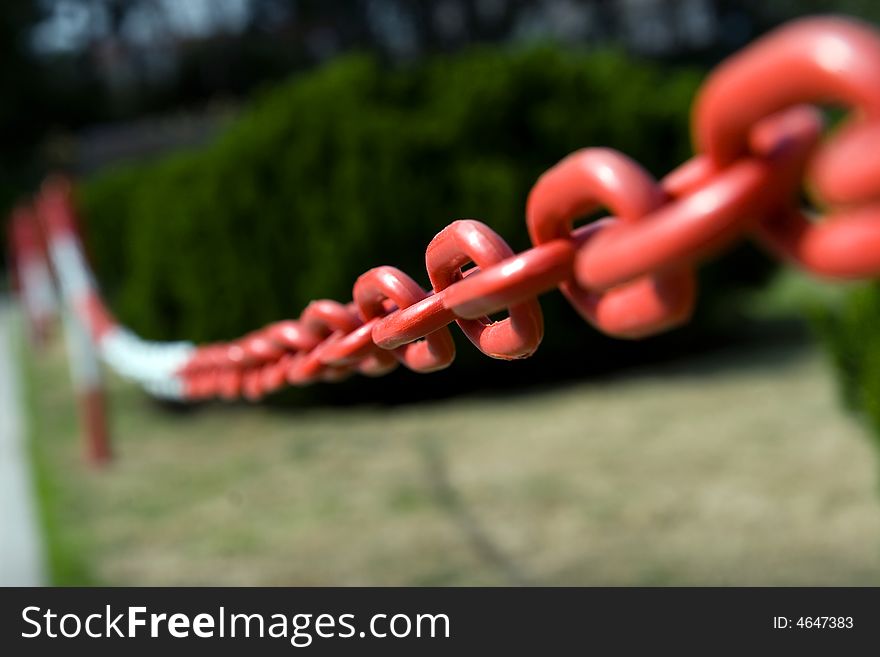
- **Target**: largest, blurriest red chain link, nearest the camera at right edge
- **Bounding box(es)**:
[694,18,880,278]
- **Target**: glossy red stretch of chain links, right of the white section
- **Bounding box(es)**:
[44,18,880,399]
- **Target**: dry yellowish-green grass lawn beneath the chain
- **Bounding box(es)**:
[27,334,880,585]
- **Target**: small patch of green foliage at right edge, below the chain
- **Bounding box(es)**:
[812,283,880,445]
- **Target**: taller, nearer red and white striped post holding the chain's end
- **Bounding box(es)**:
[36,178,111,465]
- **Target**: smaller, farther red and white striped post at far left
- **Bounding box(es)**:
[8,205,57,346]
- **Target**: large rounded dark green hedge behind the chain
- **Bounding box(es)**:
[79,48,769,400]
